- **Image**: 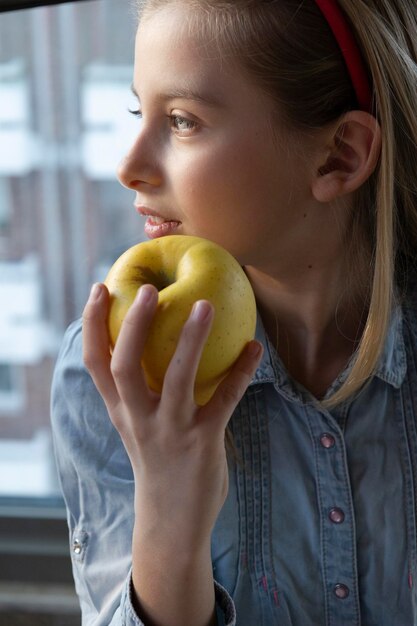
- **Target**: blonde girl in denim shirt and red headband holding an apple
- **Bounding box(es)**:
[52,0,417,626]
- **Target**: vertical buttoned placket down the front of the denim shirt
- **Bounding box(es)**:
[305,405,361,626]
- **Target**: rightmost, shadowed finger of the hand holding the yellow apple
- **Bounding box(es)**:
[202,341,263,423]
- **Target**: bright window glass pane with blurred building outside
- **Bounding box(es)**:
[0,0,143,502]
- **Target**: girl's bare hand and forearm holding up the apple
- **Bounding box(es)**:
[83,285,262,626]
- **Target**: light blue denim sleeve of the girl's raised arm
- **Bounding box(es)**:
[51,321,236,626]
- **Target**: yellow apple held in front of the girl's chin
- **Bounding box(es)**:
[105,235,256,405]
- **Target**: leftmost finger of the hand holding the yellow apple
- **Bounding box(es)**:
[83,283,118,405]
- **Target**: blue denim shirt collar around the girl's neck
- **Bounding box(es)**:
[251,305,407,397]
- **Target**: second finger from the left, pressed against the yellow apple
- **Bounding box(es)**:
[111,285,158,410]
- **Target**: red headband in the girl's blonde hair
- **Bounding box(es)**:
[315,0,372,113]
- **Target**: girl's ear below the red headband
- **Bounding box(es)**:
[311,111,381,202]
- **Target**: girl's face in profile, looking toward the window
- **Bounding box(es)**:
[119,3,318,271]
